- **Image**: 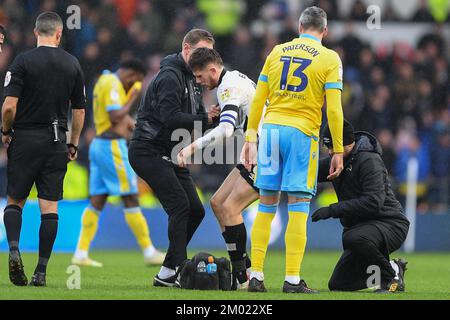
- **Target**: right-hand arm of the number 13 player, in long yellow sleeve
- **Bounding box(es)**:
[325,53,344,180]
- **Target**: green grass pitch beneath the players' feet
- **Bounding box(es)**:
[0,251,450,301]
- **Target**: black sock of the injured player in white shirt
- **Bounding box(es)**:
[224,223,248,283]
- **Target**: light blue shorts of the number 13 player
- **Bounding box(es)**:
[256,124,319,196]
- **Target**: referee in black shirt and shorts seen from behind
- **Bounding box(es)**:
[2,12,86,286]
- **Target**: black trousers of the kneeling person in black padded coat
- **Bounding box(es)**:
[328,222,408,291]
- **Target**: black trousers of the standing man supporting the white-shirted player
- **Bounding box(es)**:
[129,141,205,269]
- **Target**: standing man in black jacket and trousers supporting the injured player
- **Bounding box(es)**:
[129,29,219,287]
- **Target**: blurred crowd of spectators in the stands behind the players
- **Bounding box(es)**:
[0,0,450,212]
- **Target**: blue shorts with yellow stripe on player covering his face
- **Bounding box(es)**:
[89,138,138,196]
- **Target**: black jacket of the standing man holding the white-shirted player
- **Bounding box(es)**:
[132,53,208,152]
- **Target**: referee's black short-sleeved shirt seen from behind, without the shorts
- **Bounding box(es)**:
[4,46,86,130]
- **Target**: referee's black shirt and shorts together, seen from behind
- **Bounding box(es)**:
[4,46,86,201]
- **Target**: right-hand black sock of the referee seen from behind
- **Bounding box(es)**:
[34,213,58,273]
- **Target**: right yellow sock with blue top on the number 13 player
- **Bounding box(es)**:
[285,202,309,280]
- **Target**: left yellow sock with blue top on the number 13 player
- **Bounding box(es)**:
[251,203,278,273]
